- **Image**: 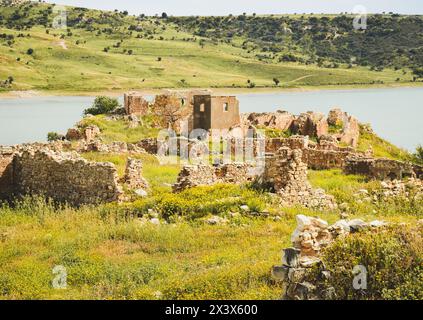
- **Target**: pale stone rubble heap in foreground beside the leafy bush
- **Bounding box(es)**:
[272,215,387,300]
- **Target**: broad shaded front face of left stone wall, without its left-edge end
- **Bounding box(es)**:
[13,150,122,206]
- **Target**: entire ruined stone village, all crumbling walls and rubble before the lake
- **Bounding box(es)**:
[0,90,423,300]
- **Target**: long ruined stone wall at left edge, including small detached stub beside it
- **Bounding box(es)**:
[0,143,149,206]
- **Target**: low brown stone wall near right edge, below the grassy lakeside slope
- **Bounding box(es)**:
[344,157,416,180]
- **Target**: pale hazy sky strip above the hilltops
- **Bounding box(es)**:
[47,0,423,15]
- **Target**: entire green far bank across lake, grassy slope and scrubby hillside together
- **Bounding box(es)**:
[0,3,421,93]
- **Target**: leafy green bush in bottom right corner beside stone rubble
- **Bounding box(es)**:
[323,225,423,300]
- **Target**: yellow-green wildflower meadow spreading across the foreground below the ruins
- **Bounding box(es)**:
[0,168,421,299]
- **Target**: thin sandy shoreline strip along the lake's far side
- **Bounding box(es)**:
[0,82,423,99]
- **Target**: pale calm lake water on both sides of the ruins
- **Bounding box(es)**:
[0,88,423,150]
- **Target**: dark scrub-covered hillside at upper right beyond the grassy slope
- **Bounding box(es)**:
[169,14,423,71]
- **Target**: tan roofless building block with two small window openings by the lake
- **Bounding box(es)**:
[194,95,241,130]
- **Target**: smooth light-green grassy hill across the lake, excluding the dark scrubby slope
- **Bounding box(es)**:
[0,3,420,92]
